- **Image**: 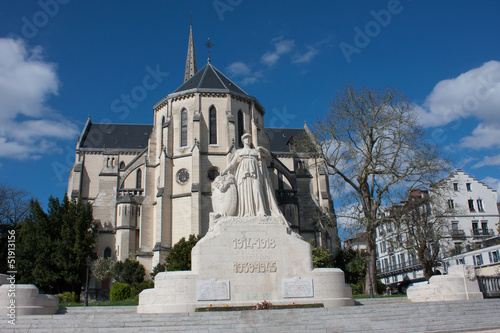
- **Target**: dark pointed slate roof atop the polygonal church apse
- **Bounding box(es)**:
[174,63,248,96]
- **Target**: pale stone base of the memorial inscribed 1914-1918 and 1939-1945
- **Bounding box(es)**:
[137,217,354,313]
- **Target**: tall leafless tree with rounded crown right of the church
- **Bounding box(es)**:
[306,84,447,292]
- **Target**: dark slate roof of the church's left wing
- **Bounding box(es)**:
[79,123,153,150]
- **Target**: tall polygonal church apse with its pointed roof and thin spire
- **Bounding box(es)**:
[143,26,265,266]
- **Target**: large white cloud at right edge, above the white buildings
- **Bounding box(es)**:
[416,60,500,127]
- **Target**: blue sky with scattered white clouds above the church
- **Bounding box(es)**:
[0,0,500,203]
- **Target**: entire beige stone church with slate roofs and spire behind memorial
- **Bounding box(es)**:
[68,29,339,271]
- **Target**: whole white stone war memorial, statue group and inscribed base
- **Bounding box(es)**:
[137,134,354,313]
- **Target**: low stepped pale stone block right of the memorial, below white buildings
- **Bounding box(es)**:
[407,265,483,302]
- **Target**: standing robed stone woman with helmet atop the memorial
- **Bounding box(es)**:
[222,133,284,219]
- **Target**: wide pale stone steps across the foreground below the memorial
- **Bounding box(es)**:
[0,298,500,333]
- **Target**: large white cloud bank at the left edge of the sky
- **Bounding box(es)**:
[0,38,78,159]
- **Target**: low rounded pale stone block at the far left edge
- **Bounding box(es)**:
[0,284,59,317]
